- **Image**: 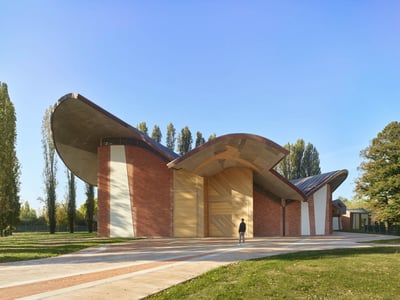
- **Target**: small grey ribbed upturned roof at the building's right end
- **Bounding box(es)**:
[290,170,348,197]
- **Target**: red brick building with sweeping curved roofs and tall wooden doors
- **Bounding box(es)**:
[51,94,348,238]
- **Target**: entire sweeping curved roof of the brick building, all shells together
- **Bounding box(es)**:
[51,93,347,201]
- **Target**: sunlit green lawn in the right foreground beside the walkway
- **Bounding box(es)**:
[148,245,400,300]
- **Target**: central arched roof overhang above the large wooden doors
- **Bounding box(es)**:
[168,133,306,200]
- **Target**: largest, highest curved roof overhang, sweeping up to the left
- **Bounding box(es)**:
[51,93,177,186]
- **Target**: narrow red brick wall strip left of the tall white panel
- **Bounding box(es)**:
[97,146,110,237]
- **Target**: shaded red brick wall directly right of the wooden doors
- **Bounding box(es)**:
[253,191,282,236]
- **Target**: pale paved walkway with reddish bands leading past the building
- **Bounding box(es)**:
[0,233,398,300]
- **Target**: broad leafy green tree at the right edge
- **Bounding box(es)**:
[355,122,400,225]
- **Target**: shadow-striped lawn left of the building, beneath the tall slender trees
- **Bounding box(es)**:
[0,232,131,263]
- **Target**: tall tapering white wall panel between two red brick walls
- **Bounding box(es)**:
[110,145,135,237]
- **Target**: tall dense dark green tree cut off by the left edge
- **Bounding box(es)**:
[0,82,20,236]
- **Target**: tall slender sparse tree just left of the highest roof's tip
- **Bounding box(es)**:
[42,106,57,234]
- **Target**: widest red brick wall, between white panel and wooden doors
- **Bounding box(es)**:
[125,146,173,237]
